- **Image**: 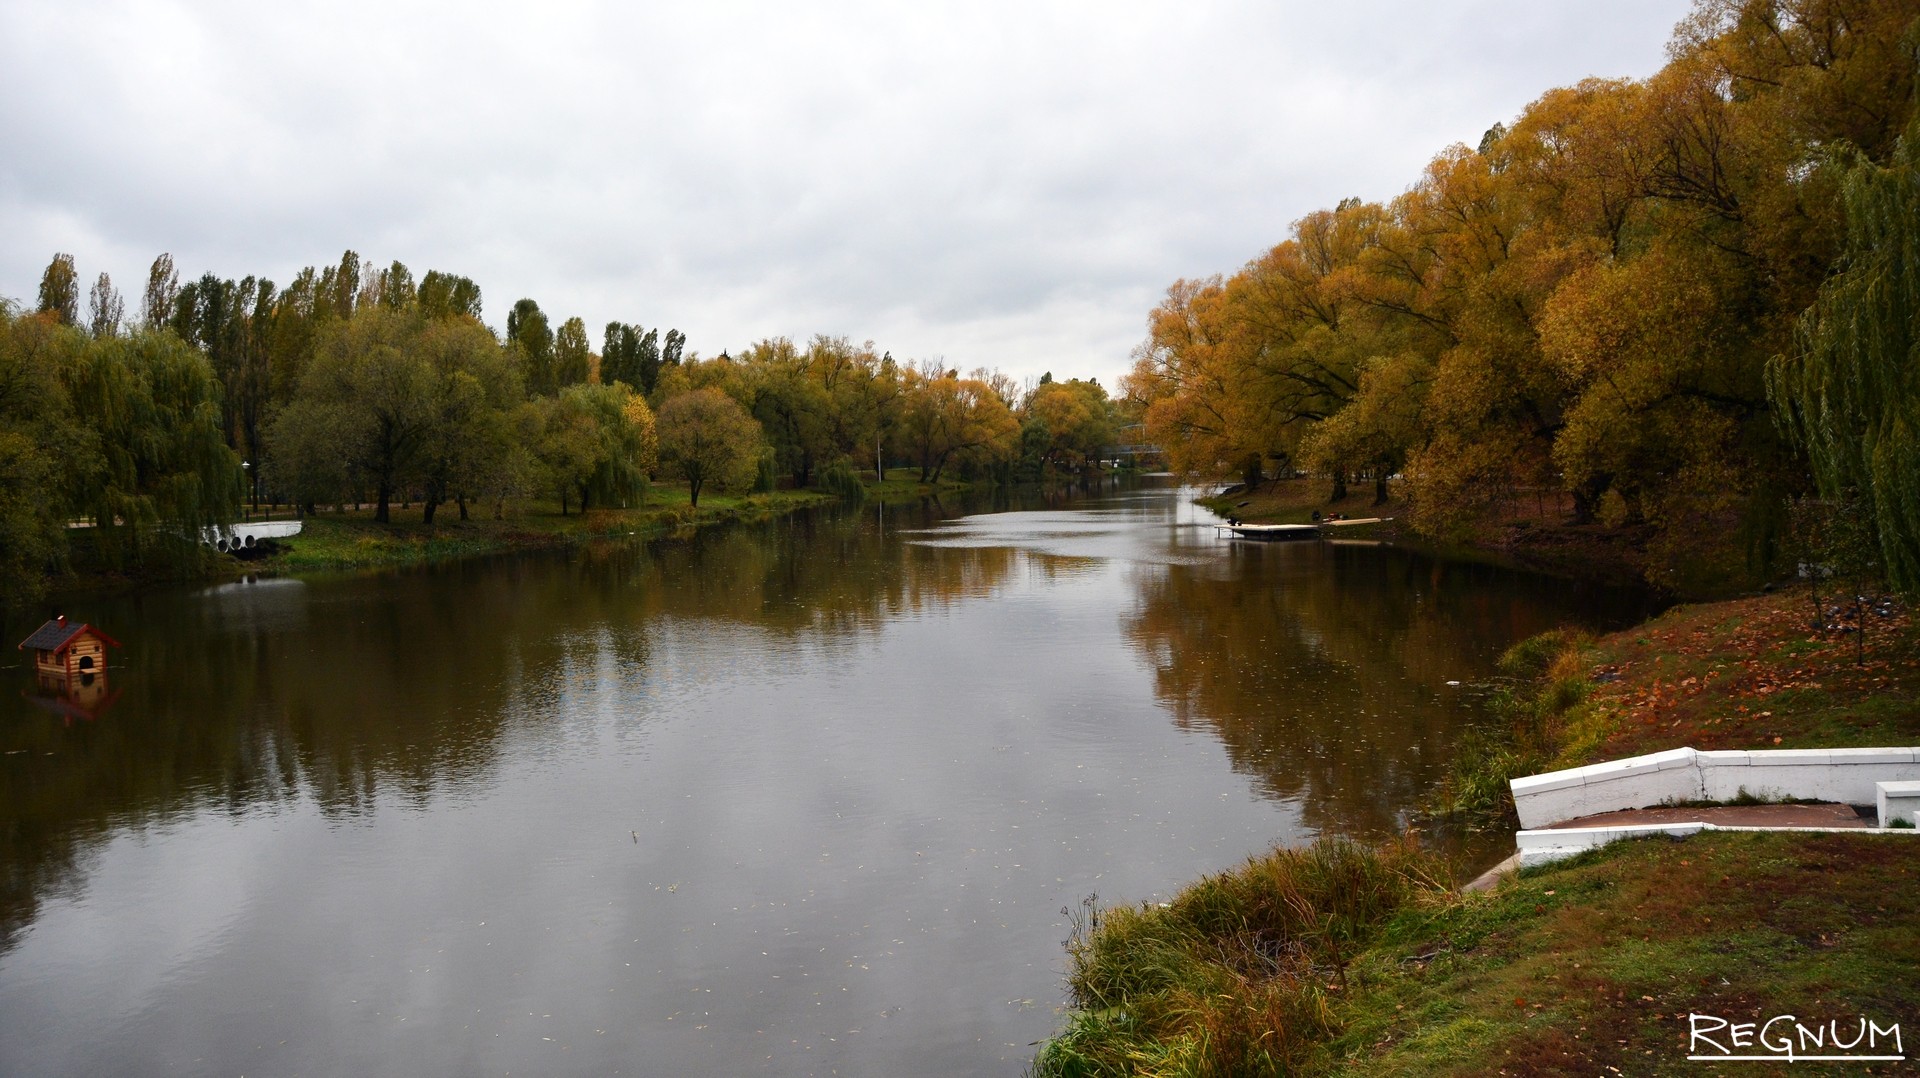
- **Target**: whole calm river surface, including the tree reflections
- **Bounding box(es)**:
[0,480,1638,1076]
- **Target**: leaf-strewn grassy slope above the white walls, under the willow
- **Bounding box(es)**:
[1442,586,1920,821]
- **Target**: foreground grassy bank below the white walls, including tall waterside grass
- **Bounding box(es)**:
[1033,832,1920,1078]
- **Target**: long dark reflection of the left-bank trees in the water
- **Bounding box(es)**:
[0,505,1016,947]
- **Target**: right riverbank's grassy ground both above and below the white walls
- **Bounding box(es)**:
[1039,586,1920,1076]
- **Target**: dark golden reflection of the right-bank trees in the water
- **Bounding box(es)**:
[1125,544,1651,832]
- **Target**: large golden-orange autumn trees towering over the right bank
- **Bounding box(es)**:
[1125,0,1920,578]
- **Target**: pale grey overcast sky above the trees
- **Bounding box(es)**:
[0,0,1690,386]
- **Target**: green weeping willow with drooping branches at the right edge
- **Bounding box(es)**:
[1766,123,1920,596]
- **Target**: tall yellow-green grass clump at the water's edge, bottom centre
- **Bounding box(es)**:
[1033,838,1444,1078]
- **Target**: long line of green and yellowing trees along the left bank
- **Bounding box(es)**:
[0,250,1123,596]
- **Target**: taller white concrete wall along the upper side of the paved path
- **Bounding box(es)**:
[1511,747,1920,828]
